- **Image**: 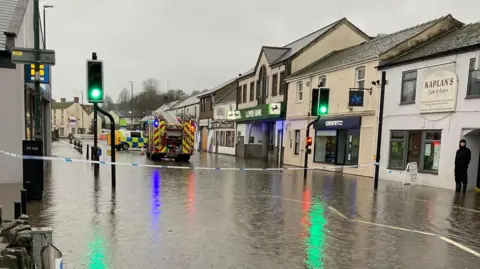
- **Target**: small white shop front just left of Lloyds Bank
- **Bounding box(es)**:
[212,120,235,155]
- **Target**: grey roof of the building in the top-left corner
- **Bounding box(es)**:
[0,0,29,50]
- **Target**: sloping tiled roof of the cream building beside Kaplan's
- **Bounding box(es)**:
[291,15,449,77]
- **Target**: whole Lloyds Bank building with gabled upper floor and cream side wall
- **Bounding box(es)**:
[235,19,369,163]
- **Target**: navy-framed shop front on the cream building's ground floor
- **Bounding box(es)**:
[313,117,362,165]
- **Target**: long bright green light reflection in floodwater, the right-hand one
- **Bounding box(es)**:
[305,198,327,269]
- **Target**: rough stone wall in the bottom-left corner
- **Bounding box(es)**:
[0,206,34,269]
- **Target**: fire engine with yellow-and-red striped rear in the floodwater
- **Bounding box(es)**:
[145,107,195,162]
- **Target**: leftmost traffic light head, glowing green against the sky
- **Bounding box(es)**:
[87,60,103,103]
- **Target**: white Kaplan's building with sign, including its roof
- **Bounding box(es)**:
[380,23,480,189]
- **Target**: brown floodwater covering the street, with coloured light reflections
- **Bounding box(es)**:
[0,141,480,269]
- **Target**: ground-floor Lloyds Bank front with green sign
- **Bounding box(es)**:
[233,102,285,163]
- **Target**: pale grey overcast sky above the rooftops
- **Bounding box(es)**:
[44,0,480,101]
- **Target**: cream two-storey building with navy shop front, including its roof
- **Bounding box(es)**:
[284,16,460,177]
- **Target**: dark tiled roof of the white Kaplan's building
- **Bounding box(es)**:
[380,22,480,67]
